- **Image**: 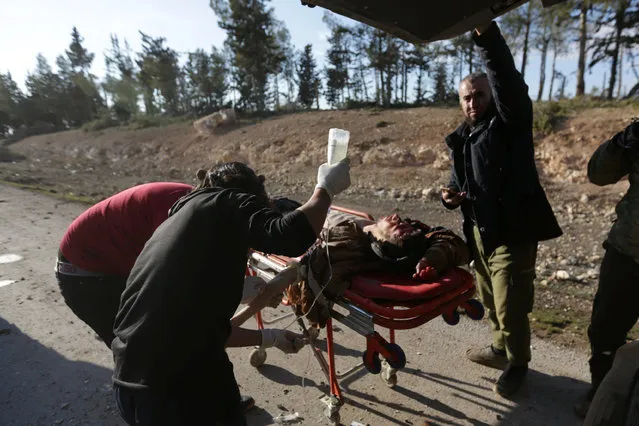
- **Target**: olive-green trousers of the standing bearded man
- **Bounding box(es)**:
[472,226,537,365]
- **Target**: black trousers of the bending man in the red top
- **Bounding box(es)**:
[56,273,126,349]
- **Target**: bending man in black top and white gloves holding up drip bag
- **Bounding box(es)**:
[112,161,350,426]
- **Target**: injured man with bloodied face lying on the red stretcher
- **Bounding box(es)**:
[234,198,470,327]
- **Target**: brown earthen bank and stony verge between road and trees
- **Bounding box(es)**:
[0,105,639,345]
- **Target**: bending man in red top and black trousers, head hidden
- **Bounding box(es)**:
[55,182,193,348]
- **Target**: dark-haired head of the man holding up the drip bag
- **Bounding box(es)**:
[195,162,268,199]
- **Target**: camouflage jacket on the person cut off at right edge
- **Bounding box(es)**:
[588,121,639,262]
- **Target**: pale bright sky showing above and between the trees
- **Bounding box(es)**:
[0,0,637,103]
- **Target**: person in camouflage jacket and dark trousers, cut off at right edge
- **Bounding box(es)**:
[575,121,639,417]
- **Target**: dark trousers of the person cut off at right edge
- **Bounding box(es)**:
[588,244,639,396]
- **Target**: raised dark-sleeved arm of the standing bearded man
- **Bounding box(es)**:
[473,22,532,125]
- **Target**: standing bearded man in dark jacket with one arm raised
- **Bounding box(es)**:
[442,22,562,397]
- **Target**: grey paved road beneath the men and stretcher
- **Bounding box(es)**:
[0,186,587,426]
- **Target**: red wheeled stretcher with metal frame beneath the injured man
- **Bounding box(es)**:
[247,206,484,423]
